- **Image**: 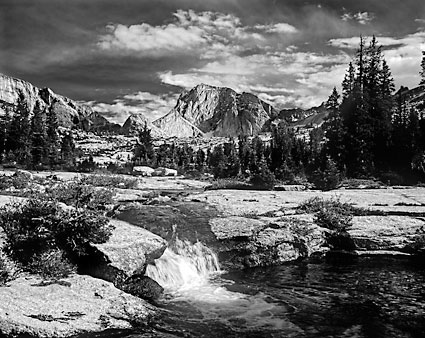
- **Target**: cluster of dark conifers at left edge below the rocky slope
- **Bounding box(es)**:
[0,92,75,169]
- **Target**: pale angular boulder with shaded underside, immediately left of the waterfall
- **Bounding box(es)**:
[86,220,167,286]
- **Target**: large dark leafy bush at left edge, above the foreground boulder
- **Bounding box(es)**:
[0,198,112,275]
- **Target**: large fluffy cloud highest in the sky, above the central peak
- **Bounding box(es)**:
[98,10,297,58]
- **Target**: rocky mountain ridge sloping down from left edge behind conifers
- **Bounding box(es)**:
[0,74,120,131]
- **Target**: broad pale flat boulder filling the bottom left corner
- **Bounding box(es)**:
[0,275,155,338]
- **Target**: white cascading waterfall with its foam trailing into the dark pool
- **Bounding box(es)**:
[146,239,297,331]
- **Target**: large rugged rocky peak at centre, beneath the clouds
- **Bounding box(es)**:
[153,84,276,137]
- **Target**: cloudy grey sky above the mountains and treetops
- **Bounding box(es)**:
[0,0,425,123]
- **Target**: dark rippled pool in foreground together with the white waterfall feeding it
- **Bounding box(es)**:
[96,241,425,338]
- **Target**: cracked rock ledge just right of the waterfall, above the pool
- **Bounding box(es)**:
[210,217,328,268]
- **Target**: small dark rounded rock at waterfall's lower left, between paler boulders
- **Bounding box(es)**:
[121,275,164,301]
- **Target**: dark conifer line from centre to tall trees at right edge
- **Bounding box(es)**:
[134,37,425,189]
